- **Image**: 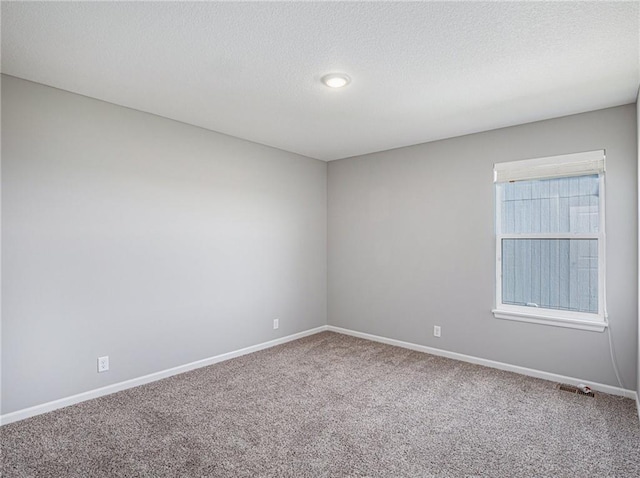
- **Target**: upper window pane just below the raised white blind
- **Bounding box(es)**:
[498,174,600,234]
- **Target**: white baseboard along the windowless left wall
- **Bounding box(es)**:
[0,325,327,425]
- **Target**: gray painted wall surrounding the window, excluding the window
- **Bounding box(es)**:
[328,105,638,389]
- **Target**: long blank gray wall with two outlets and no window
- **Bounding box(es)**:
[2,76,327,413]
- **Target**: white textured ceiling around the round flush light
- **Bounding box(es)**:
[2,1,640,160]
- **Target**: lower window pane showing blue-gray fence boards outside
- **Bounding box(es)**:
[502,239,598,314]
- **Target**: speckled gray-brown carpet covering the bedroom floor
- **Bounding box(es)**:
[0,332,640,478]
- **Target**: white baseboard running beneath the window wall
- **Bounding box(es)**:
[327,325,640,400]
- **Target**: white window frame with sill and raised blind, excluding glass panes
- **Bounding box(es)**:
[492,150,608,332]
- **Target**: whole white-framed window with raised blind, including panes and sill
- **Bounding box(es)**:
[493,151,606,331]
